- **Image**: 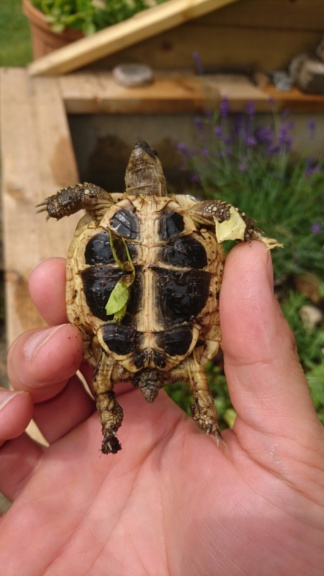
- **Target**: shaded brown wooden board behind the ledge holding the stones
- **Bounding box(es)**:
[95,20,321,73]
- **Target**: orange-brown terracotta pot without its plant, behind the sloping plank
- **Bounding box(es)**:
[23,0,83,60]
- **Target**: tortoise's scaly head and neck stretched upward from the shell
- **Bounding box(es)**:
[125,141,167,196]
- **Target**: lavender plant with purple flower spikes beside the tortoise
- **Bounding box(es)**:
[178,99,324,280]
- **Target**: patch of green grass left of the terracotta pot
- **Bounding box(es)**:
[0,0,32,66]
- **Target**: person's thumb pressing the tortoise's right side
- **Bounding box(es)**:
[220,242,321,444]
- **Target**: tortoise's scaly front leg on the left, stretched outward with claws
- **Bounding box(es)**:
[37,182,114,222]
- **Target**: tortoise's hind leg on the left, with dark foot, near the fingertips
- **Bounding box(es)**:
[93,352,124,454]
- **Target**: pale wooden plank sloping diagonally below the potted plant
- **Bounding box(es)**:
[29,0,237,75]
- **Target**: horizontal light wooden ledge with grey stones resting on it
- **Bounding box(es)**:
[59,72,324,115]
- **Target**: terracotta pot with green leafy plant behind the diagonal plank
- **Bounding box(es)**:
[23,0,164,59]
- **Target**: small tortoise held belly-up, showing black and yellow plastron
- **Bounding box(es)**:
[38,141,276,454]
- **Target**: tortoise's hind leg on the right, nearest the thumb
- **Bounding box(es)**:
[186,358,222,442]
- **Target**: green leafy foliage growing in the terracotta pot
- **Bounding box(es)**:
[32,0,164,35]
